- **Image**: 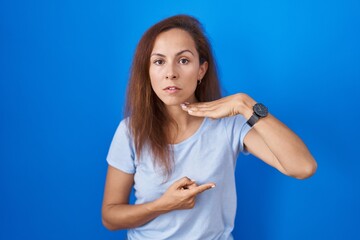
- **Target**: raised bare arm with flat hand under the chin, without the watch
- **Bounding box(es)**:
[182,94,317,179]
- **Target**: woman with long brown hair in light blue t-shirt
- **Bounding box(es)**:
[102,15,316,240]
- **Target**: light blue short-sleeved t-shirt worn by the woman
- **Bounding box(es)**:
[107,115,250,240]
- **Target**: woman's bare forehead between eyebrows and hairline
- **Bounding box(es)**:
[152,28,197,54]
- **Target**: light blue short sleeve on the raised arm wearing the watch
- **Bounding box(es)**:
[225,114,251,155]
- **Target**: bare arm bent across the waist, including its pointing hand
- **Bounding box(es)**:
[102,166,214,230]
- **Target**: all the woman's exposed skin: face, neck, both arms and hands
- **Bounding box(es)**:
[102,29,316,230]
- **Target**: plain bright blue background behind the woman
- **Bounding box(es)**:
[0,0,360,240]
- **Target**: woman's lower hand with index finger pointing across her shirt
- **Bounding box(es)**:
[156,177,215,211]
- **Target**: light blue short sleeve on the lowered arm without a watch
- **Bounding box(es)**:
[106,119,135,174]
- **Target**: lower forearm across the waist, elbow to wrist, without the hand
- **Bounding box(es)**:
[102,201,167,230]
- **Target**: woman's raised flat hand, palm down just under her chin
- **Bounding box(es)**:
[181,93,256,119]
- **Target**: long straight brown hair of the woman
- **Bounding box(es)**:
[125,15,221,176]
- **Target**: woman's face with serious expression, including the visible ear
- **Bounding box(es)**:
[149,28,208,106]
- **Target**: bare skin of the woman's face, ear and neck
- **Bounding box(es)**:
[149,29,208,143]
